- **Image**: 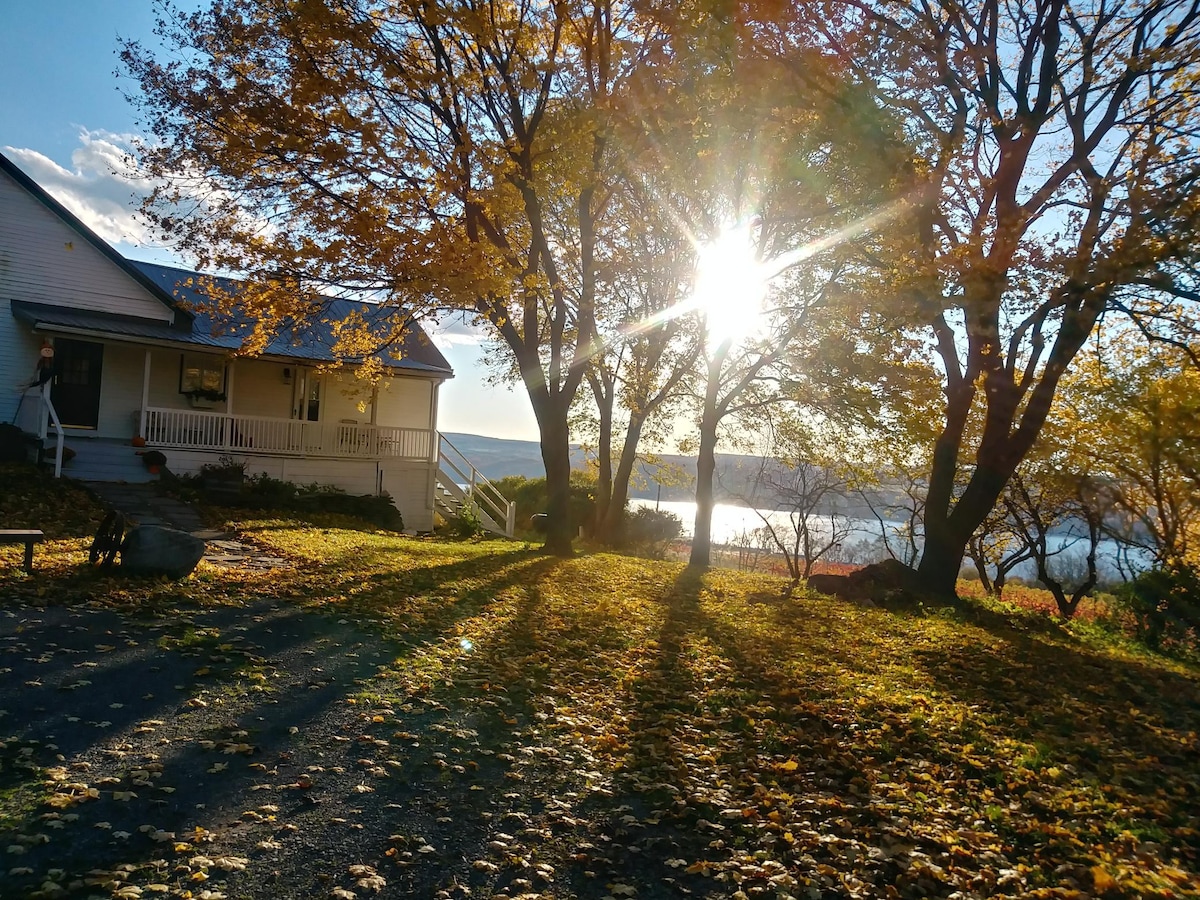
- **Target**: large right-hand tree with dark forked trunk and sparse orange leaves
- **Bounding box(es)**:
[820,0,1200,593]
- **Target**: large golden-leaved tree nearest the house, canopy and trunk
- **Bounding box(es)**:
[122,0,676,552]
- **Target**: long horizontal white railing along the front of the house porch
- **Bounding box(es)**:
[144,407,434,462]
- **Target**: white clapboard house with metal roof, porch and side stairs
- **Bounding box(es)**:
[0,155,512,534]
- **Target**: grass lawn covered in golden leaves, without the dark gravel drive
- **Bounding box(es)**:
[0,487,1200,898]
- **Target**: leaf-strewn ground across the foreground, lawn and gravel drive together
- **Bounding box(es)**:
[0,473,1200,900]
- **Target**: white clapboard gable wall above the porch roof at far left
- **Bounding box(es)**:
[0,172,172,322]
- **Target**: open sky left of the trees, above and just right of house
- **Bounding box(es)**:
[0,0,538,440]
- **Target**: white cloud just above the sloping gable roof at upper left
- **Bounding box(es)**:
[4,130,161,247]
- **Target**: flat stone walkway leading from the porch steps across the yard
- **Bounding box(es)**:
[84,481,290,569]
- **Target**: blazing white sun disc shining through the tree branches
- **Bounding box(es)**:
[694,224,767,349]
